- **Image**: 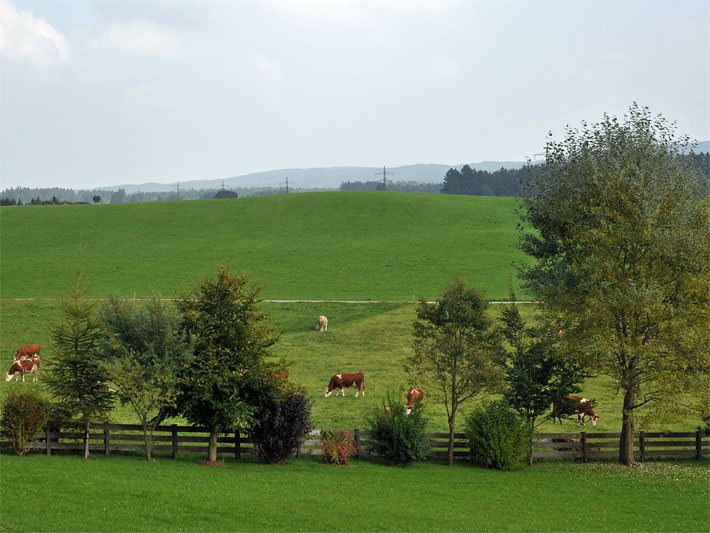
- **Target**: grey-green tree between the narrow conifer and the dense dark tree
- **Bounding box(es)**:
[99,298,192,461]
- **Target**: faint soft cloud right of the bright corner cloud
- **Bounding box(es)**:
[105,19,182,57]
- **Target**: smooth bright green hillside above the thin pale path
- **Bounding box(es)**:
[0,192,524,300]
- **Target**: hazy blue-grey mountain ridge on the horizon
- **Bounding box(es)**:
[101,161,526,194]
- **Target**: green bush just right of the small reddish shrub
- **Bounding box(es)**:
[368,394,429,466]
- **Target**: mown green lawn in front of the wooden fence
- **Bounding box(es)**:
[0,454,710,531]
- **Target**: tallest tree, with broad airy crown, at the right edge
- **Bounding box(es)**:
[523,104,710,465]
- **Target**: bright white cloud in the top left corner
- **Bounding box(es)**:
[0,0,69,65]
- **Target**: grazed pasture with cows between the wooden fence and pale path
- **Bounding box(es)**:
[0,301,701,432]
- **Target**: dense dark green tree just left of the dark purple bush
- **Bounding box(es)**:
[177,266,276,463]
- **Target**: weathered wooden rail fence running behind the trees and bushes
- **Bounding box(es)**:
[0,424,710,462]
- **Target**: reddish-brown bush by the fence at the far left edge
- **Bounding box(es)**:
[0,390,50,455]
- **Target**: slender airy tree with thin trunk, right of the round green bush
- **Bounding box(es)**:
[409,276,503,464]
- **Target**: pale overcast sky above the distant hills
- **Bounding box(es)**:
[0,0,710,188]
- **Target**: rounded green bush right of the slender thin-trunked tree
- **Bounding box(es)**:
[466,401,531,470]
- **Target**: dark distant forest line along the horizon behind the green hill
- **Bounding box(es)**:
[0,152,710,205]
